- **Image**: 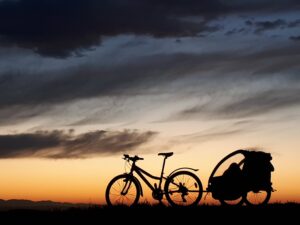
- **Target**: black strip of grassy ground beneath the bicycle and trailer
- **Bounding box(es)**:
[0,203,300,225]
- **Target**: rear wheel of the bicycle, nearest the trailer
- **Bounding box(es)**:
[165,171,203,206]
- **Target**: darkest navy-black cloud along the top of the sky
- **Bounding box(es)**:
[0,0,299,57]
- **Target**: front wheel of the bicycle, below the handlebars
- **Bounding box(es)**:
[105,174,140,206]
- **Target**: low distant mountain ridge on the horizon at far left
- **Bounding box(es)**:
[0,199,95,211]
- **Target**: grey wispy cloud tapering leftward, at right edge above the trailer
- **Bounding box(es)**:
[166,89,300,121]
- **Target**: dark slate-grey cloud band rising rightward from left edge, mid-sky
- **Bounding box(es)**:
[0,51,229,109]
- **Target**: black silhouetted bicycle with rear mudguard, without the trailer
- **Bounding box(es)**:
[105,152,203,206]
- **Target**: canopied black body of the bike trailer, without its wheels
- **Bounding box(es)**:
[208,150,274,200]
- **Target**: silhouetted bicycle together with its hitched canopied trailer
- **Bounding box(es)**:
[105,149,274,206]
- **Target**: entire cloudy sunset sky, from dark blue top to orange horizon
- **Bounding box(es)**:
[0,0,300,204]
